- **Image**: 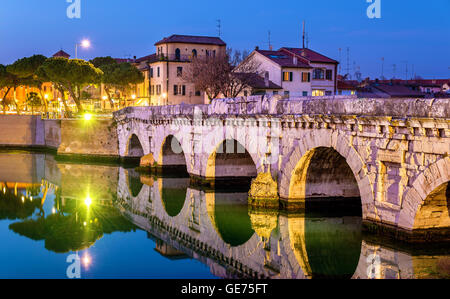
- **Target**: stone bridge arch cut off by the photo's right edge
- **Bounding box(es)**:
[398,157,450,231]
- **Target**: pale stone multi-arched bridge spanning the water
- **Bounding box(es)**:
[114,97,450,241]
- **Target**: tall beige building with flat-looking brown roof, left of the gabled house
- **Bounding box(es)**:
[135,35,226,105]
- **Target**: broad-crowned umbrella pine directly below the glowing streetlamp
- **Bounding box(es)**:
[38,57,103,113]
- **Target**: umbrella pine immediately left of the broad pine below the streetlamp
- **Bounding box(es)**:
[7,55,48,112]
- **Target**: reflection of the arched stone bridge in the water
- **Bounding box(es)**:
[114,168,448,279]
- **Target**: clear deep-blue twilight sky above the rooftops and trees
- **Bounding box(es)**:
[0,0,450,78]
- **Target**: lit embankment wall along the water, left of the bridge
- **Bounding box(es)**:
[0,115,121,163]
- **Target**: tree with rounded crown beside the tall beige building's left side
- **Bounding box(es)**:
[100,62,144,107]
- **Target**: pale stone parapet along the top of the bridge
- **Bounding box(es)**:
[114,96,450,119]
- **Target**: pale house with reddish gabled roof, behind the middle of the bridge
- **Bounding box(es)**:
[239,47,339,97]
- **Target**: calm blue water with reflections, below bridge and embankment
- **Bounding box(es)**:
[0,152,450,278]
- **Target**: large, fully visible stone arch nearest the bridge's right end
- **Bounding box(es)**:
[279,130,374,214]
